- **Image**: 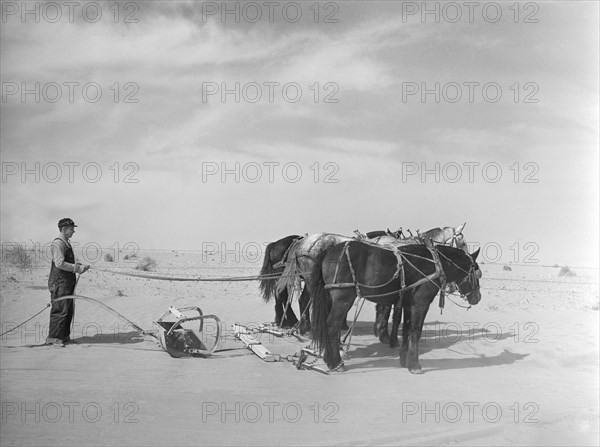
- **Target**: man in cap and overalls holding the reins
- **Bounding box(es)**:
[46,217,90,347]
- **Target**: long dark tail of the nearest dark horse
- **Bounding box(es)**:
[310,250,331,351]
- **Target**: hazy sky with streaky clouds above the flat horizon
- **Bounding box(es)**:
[0,1,599,267]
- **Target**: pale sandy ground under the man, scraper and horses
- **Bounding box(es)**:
[0,252,599,446]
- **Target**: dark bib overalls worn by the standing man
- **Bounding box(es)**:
[48,238,76,341]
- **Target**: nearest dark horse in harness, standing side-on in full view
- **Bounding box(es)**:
[311,241,481,374]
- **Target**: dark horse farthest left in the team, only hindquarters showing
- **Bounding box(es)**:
[259,234,302,328]
